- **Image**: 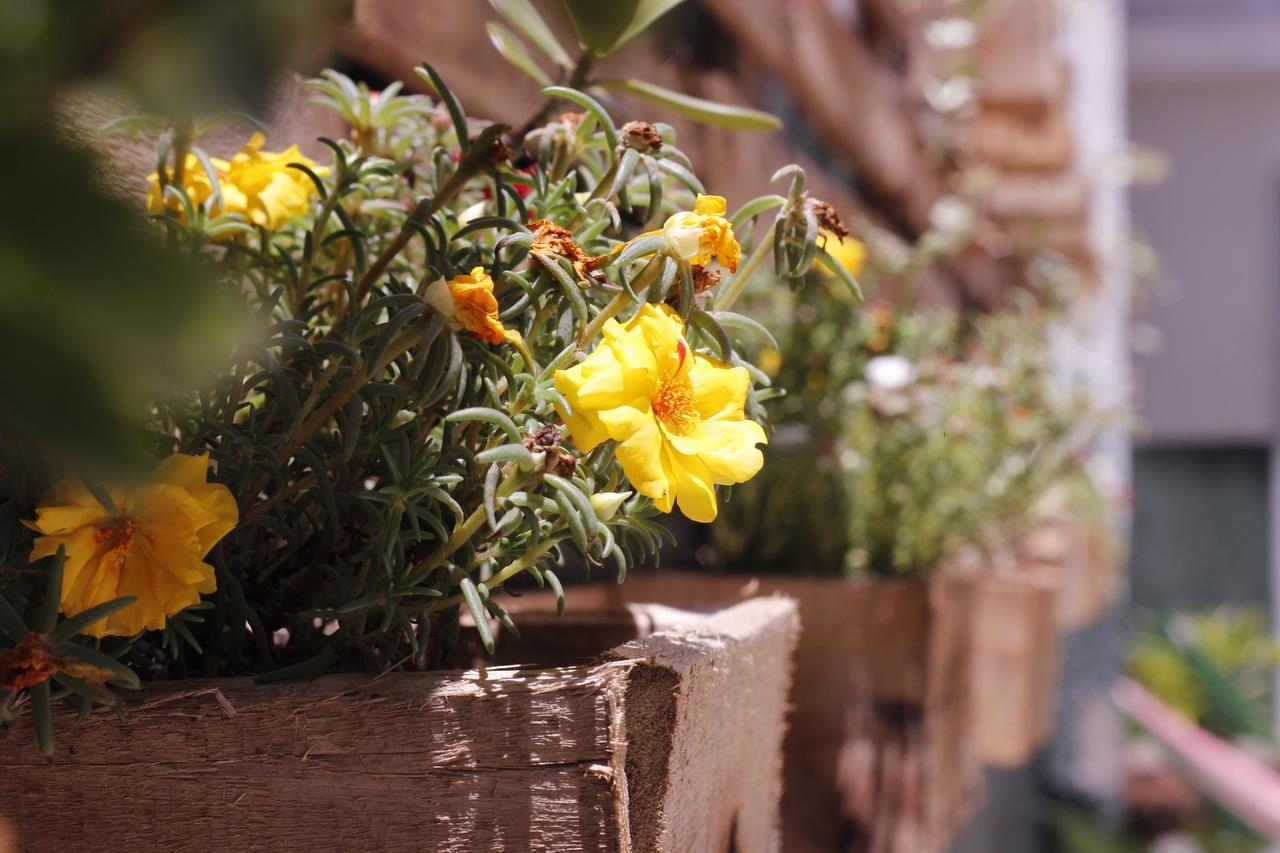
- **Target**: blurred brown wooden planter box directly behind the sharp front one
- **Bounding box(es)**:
[522,571,980,853]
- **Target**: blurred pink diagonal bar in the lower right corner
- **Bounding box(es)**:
[1111,679,1280,839]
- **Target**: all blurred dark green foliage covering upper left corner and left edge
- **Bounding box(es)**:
[0,0,342,473]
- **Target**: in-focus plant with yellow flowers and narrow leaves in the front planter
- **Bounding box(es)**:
[0,41,855,751]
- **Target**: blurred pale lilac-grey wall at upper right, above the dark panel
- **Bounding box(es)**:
[1129,18,1280,443]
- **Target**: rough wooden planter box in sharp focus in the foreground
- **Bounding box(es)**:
[0,598,797,853]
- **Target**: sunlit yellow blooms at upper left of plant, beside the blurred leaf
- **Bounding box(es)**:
[147,133,329,229]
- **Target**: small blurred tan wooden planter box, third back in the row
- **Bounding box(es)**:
[973,570,1061,767]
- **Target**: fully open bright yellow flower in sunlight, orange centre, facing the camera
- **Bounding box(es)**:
[556,304,765,521]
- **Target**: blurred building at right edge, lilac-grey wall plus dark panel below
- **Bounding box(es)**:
[1129,0,1280,607]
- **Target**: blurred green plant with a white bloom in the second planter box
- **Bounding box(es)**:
[712,239,1098,575]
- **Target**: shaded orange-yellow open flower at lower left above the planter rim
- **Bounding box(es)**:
[27,453,238,637]
